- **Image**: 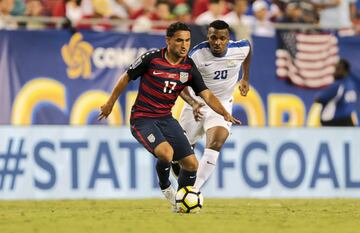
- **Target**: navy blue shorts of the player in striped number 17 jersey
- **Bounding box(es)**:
[130,116,194,161]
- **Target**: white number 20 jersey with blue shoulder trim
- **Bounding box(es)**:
[189,40,250,102]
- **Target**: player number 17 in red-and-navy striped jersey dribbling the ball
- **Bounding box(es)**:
[98,22,240,211]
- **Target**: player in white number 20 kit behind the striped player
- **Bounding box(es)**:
[172,20,251,189]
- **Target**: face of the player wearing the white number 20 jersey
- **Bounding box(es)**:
[207,27,230,56]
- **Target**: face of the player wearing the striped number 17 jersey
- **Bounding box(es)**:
[166,31,191,58]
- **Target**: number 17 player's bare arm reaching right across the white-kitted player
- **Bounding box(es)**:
[199,89,241,125]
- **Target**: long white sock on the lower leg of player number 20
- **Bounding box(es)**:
[194,148,219,189]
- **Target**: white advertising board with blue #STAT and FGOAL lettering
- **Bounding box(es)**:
[0,126,360,199]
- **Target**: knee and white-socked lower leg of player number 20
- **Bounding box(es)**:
[194,126,229,189]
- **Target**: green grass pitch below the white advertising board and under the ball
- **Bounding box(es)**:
[0,199,360,233]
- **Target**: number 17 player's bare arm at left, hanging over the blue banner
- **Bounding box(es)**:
[97,72,130,121]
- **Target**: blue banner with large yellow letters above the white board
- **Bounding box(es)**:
[0,30,360,127]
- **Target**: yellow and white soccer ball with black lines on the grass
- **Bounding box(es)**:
[175,186,204,213]
